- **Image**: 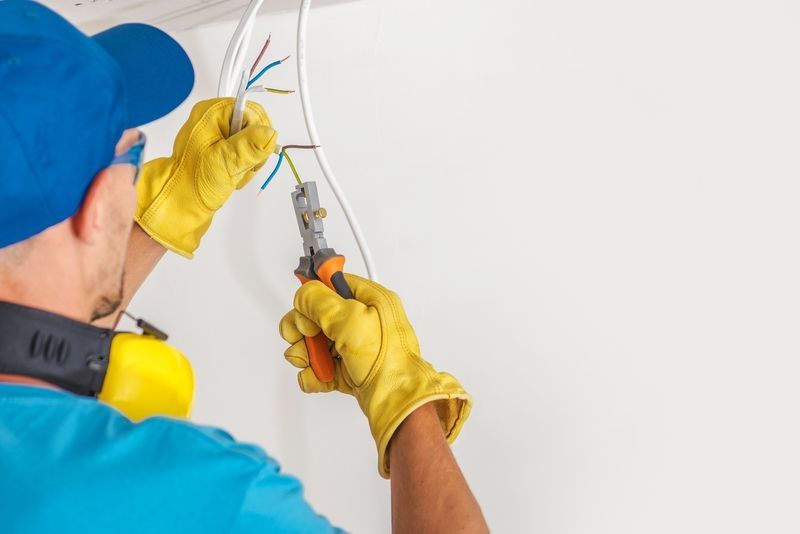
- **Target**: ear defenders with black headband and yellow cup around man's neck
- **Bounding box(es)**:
[0,302,194,421]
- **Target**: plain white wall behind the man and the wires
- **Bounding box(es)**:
[134,0,800,534]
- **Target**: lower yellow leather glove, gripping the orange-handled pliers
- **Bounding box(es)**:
[280,275,472,478]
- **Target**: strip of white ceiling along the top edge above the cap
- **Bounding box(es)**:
[40,0,347,34]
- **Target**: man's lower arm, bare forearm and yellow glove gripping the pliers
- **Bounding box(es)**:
[280,275,488,533]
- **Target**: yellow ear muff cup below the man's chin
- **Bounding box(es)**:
[97,333,194,421]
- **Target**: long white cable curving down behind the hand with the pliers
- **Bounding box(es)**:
[297,0,378,281]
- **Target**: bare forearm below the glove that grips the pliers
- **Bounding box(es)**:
[389,404,489,534]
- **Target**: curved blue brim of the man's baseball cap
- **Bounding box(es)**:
[92,24,194,128]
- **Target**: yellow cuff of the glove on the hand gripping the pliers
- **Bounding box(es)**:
[370,382,472,479]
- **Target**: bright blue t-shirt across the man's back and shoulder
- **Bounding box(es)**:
[0,384,341,534]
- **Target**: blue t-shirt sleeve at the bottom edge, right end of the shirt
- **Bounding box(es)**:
[231,463,345,534]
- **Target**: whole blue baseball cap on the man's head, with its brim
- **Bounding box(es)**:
[0,0,194,248]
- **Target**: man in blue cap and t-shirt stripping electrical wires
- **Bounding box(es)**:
[0,0,487,534]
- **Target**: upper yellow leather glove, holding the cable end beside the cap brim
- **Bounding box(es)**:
[135,98,278,258]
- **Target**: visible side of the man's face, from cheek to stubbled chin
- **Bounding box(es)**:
[92,129,139,321]
